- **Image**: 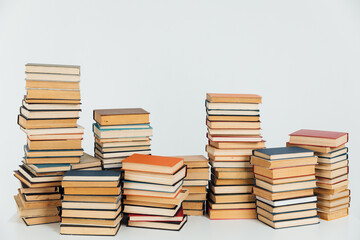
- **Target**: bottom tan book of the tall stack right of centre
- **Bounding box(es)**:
[208,208,257,220]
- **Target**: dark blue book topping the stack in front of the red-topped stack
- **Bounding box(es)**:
[253,147,314,160]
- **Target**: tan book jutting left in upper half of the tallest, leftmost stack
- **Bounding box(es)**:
[18,115,78,129]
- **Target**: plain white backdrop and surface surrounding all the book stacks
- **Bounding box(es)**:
[0,0,360,239]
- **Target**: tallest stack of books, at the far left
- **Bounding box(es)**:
[14,64,84,225]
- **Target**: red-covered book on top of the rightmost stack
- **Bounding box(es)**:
[289,129,349,147]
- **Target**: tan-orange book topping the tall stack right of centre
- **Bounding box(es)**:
[206,93,261,103]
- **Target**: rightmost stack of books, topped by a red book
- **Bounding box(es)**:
[287,129,350,221]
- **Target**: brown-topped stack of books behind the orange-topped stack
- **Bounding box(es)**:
[93,108,152,170]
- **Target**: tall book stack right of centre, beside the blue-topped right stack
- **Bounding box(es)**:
[206,93,265,219]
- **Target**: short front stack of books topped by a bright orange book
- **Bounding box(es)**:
[123,154,188,230]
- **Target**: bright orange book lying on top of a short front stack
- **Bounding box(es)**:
[122,154,184,174]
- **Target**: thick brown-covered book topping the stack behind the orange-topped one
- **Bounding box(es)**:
[93,108,150,126]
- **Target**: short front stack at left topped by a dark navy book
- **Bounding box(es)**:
[60,170,122,236]
